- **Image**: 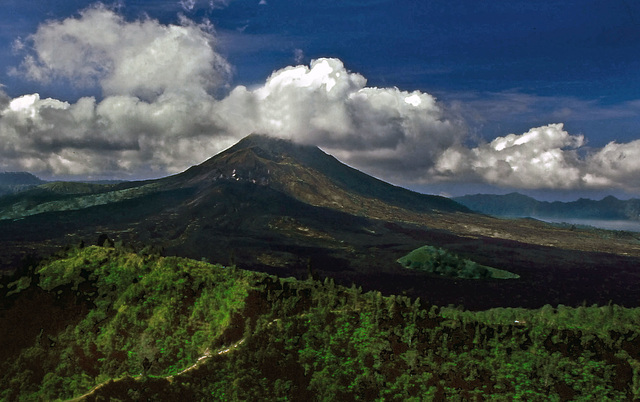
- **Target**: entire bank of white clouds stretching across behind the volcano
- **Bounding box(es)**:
[0,2,640,191]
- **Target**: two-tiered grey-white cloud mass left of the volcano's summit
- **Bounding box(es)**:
[0,5,236,177]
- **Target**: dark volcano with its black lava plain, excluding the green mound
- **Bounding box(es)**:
[0,135,640,308]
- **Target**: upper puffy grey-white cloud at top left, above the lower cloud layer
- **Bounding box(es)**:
[16,5,230,99]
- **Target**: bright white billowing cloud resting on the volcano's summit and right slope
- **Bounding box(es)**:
[212,59,464,177]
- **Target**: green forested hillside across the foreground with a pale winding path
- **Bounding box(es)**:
[0,242,640,401]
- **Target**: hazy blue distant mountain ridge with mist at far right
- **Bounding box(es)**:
[454,193,640,221]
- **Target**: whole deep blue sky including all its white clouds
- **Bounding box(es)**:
[0,0,640,200]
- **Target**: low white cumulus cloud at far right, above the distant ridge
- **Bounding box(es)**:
[432,124,640,189]
